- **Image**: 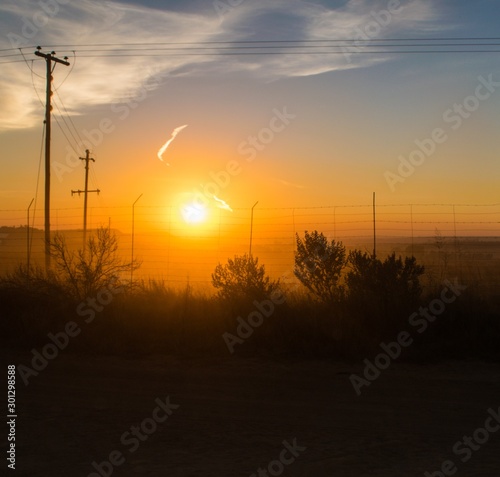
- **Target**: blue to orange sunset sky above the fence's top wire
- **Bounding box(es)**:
[0,0,500,234]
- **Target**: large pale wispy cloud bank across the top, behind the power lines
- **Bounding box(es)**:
[0,0,448,130]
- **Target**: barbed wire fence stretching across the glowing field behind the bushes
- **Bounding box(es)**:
[0,204,500,286]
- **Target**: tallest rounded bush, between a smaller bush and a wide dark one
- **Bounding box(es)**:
[293,230,346,303]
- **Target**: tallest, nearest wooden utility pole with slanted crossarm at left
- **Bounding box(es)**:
[35,46,69,270]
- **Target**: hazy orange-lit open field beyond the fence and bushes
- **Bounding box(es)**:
[0,227,500,291]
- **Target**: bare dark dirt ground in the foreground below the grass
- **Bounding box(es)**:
[2,354,500,477]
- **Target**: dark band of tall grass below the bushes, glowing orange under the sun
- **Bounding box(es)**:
[0,267,500,360]
